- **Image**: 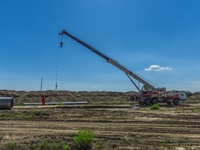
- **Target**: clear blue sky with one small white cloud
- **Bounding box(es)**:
[0,0,200,92]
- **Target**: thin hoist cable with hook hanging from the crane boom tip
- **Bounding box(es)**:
[55,34,63,91]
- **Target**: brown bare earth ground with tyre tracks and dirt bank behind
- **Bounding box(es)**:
[0,91,200,150]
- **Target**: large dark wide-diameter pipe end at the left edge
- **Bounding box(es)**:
[0,97,13,110]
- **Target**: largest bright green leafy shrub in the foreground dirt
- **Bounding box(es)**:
[73,130,94,150]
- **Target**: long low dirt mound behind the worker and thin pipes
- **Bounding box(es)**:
[0,90,138,105]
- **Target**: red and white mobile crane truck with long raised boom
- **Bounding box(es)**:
[59,30,186,106]
